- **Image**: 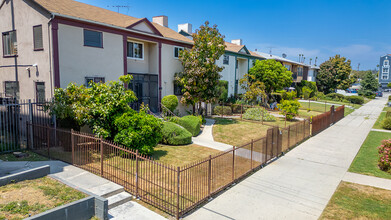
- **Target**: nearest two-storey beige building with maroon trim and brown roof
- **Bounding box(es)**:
[0,0,192,111]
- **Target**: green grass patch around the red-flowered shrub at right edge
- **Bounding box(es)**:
[349,131,391,179]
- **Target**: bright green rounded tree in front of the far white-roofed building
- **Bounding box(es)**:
[248,60,292,94]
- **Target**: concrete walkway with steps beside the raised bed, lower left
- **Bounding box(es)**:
[0,160,165,220]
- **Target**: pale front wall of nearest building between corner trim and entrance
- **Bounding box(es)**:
[58,24,124,88]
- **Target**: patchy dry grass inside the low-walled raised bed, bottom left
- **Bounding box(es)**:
[0,177,86,219]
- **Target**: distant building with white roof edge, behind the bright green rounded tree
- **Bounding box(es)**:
[255,51,310,83]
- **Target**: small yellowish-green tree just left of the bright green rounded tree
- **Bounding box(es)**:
[240,74,266,103]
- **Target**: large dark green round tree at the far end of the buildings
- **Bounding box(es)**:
[316,55,355,94]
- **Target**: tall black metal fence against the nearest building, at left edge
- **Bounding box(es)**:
[0,98,53,153]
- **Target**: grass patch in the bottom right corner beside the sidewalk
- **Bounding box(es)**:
[319,182,391,219]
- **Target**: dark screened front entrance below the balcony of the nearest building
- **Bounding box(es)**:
[129,74,159,112]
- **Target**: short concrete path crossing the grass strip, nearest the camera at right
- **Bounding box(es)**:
[342,172,391,190]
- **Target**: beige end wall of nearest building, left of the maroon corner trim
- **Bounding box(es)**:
[0,0,53,99]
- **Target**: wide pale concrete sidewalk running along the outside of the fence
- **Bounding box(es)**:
[187,97,387,220]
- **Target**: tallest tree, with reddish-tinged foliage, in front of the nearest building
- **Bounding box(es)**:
[176,21,225,114]
